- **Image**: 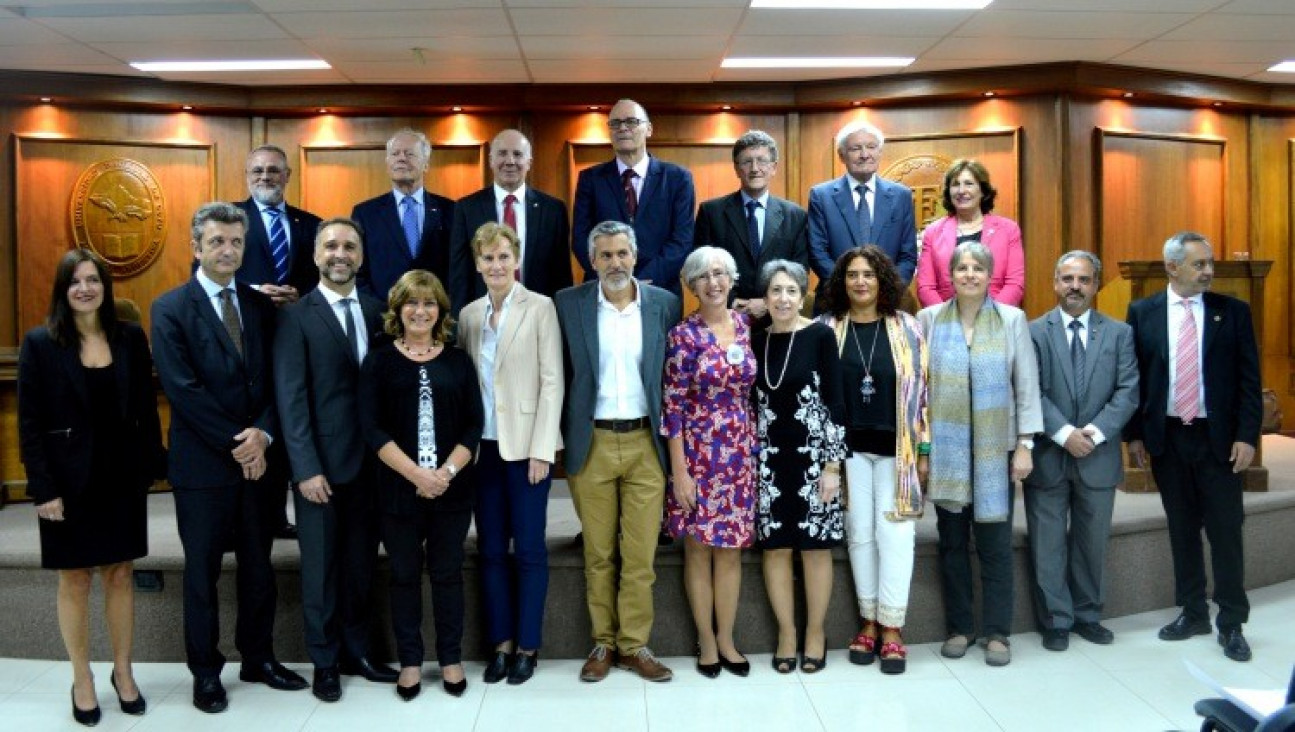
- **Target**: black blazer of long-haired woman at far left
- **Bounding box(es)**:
[18,323,166,504]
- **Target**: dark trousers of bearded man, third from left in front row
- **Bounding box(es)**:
[293,482,378,669]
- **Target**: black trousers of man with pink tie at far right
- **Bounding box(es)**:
[1151,418,1250,628]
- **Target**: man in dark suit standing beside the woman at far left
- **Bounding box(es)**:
[153,203,306,713]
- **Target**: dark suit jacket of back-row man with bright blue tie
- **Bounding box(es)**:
[352,189,455,302]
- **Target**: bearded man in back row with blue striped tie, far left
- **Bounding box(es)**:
[234,145,320,306]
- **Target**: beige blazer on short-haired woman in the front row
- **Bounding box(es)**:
[458,282,565,463]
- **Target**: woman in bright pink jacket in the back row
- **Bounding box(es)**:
[917,159,1026,307]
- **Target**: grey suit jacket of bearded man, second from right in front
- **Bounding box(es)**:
[1027,307,1138,488]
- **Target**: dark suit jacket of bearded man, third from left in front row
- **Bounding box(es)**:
[275,288,385,485]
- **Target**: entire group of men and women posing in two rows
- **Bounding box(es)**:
[19,100,1260,724]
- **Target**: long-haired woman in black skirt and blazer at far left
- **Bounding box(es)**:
[18,249,166,726]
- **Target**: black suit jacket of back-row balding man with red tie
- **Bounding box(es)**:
[448,185,572,316]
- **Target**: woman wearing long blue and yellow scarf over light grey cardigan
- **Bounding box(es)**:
[917,241,1044,666]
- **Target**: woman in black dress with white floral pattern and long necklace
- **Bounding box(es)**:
[751,259,846,674]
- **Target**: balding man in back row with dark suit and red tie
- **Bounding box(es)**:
[447,130,571,310]
